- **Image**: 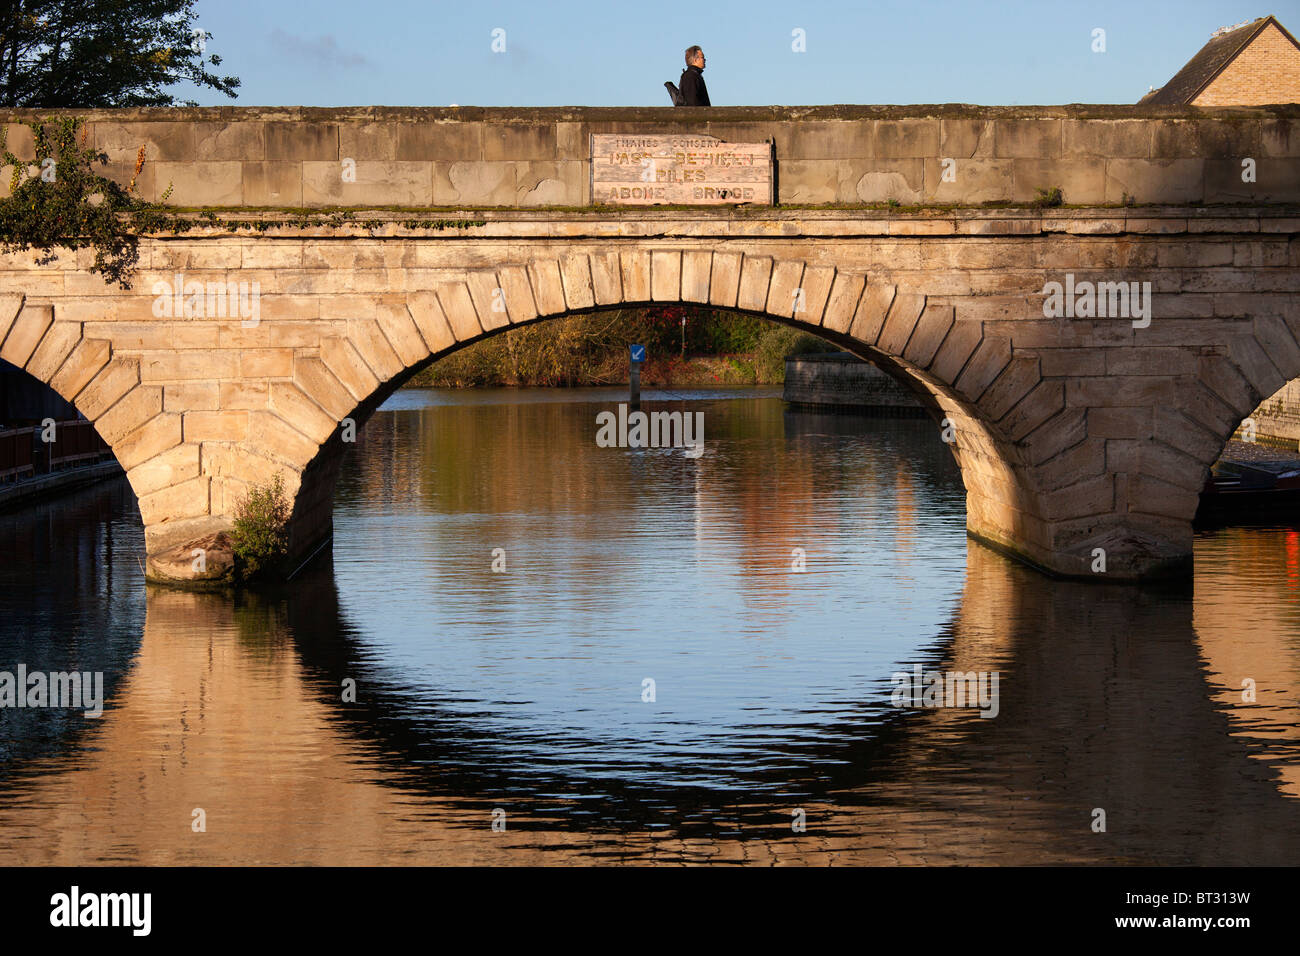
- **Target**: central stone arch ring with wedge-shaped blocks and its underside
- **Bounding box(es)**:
[279,247,1062,580]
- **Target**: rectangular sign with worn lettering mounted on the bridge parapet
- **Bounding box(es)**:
[592,133,772,206]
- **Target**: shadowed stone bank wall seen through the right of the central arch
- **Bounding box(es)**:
[781,352,926,416]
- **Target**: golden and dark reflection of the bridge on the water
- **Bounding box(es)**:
[0,530,1297,864]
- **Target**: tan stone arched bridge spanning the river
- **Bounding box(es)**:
[0,107,1300,578]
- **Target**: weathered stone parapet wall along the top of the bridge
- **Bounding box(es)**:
[0,104,1300,208]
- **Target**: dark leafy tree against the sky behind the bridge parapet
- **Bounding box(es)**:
[0,0,239,109]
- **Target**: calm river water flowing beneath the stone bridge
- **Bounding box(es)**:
[0,389,1300,865]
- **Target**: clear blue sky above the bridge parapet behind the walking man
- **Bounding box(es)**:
[181,0,1300,107]
